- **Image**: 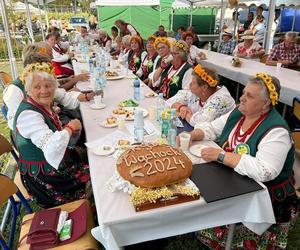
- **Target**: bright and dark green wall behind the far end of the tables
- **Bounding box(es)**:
[97,0,216,39]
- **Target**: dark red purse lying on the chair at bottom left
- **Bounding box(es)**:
[19,202,87,250]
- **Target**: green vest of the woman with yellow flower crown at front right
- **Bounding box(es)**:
[219,108,295,200]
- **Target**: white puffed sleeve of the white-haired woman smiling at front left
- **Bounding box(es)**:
[17,110,70,169]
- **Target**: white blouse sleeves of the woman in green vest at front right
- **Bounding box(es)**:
[195,112,292,182]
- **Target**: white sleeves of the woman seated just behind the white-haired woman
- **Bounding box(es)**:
[3,84,81,130]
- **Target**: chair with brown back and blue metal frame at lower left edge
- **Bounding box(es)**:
[0,175,32,250]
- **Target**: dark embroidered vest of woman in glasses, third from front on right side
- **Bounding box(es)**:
[159,63,191,99]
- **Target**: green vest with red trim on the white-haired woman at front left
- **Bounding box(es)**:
[14,101,57,176]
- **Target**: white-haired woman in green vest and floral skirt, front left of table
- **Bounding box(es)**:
[14,63,90,207]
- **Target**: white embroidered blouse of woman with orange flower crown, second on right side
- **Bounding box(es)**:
[166,86,235,127]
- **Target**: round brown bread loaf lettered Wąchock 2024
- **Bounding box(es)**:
[117,144,192,188]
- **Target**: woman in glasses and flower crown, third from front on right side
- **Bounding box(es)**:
[153,40,193,99]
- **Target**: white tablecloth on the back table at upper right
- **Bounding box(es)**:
[201,50,300,106]
